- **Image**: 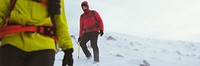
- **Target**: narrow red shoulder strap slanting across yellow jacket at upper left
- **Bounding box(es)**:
[4,0,17,26]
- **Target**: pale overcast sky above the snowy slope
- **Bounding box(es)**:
[65,0,200,42]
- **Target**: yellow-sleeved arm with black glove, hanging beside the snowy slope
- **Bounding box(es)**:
[55,0,74,66]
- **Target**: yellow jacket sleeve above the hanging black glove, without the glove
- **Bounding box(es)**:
[55,0,73,50]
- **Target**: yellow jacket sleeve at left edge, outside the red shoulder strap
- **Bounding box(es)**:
[0,0,10,27]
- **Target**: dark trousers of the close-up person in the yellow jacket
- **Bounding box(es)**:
[0,45,55,66]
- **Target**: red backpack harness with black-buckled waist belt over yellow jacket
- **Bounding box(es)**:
[0,0,57,40]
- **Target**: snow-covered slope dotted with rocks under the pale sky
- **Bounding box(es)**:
[54,32,200,66]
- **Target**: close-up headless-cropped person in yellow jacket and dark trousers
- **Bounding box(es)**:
[0,0,73,66]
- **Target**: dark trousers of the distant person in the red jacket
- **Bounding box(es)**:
[80,32,99,62]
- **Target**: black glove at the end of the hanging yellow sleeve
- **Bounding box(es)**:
[62,48,74,66]
